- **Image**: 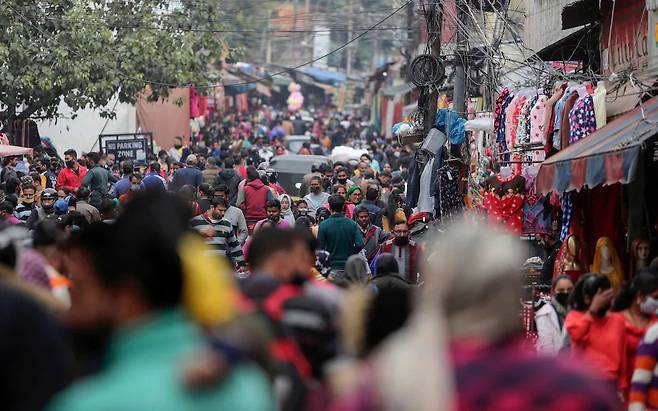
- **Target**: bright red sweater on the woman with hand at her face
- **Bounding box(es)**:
[564,310,628,389]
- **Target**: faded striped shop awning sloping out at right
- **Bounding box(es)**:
[537,97,658,194]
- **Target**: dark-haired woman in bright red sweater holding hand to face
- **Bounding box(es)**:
[564,273,630,393]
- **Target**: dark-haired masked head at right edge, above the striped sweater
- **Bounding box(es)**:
[612,268,658,316]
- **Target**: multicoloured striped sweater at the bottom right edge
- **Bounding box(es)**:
[628,324,658,411]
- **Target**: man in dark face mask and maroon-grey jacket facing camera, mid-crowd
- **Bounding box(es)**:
[375,220,422,284]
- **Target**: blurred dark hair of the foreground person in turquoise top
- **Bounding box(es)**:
[66,192,191,309]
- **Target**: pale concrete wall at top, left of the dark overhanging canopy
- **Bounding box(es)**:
[524,0,579,52]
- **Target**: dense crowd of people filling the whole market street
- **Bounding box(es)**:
[0,110,658,411]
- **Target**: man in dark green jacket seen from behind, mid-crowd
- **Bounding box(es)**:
[318,194,363,271]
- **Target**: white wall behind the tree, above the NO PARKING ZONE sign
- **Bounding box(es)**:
[37,99,136,155]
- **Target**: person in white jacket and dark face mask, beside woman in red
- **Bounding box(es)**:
[535,275,573,355]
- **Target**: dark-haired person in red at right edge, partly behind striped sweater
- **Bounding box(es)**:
[612,272,658,387]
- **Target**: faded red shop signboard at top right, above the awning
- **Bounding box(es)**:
[600,0,653,75]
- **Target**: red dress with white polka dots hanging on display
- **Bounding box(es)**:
[482,175,525,235]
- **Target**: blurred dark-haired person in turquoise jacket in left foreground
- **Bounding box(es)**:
[49,194,273,411]
